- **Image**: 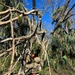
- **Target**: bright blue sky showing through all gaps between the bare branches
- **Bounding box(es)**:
[23,0,75,32]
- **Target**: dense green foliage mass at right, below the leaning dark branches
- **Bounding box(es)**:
[48,29,75,70]
